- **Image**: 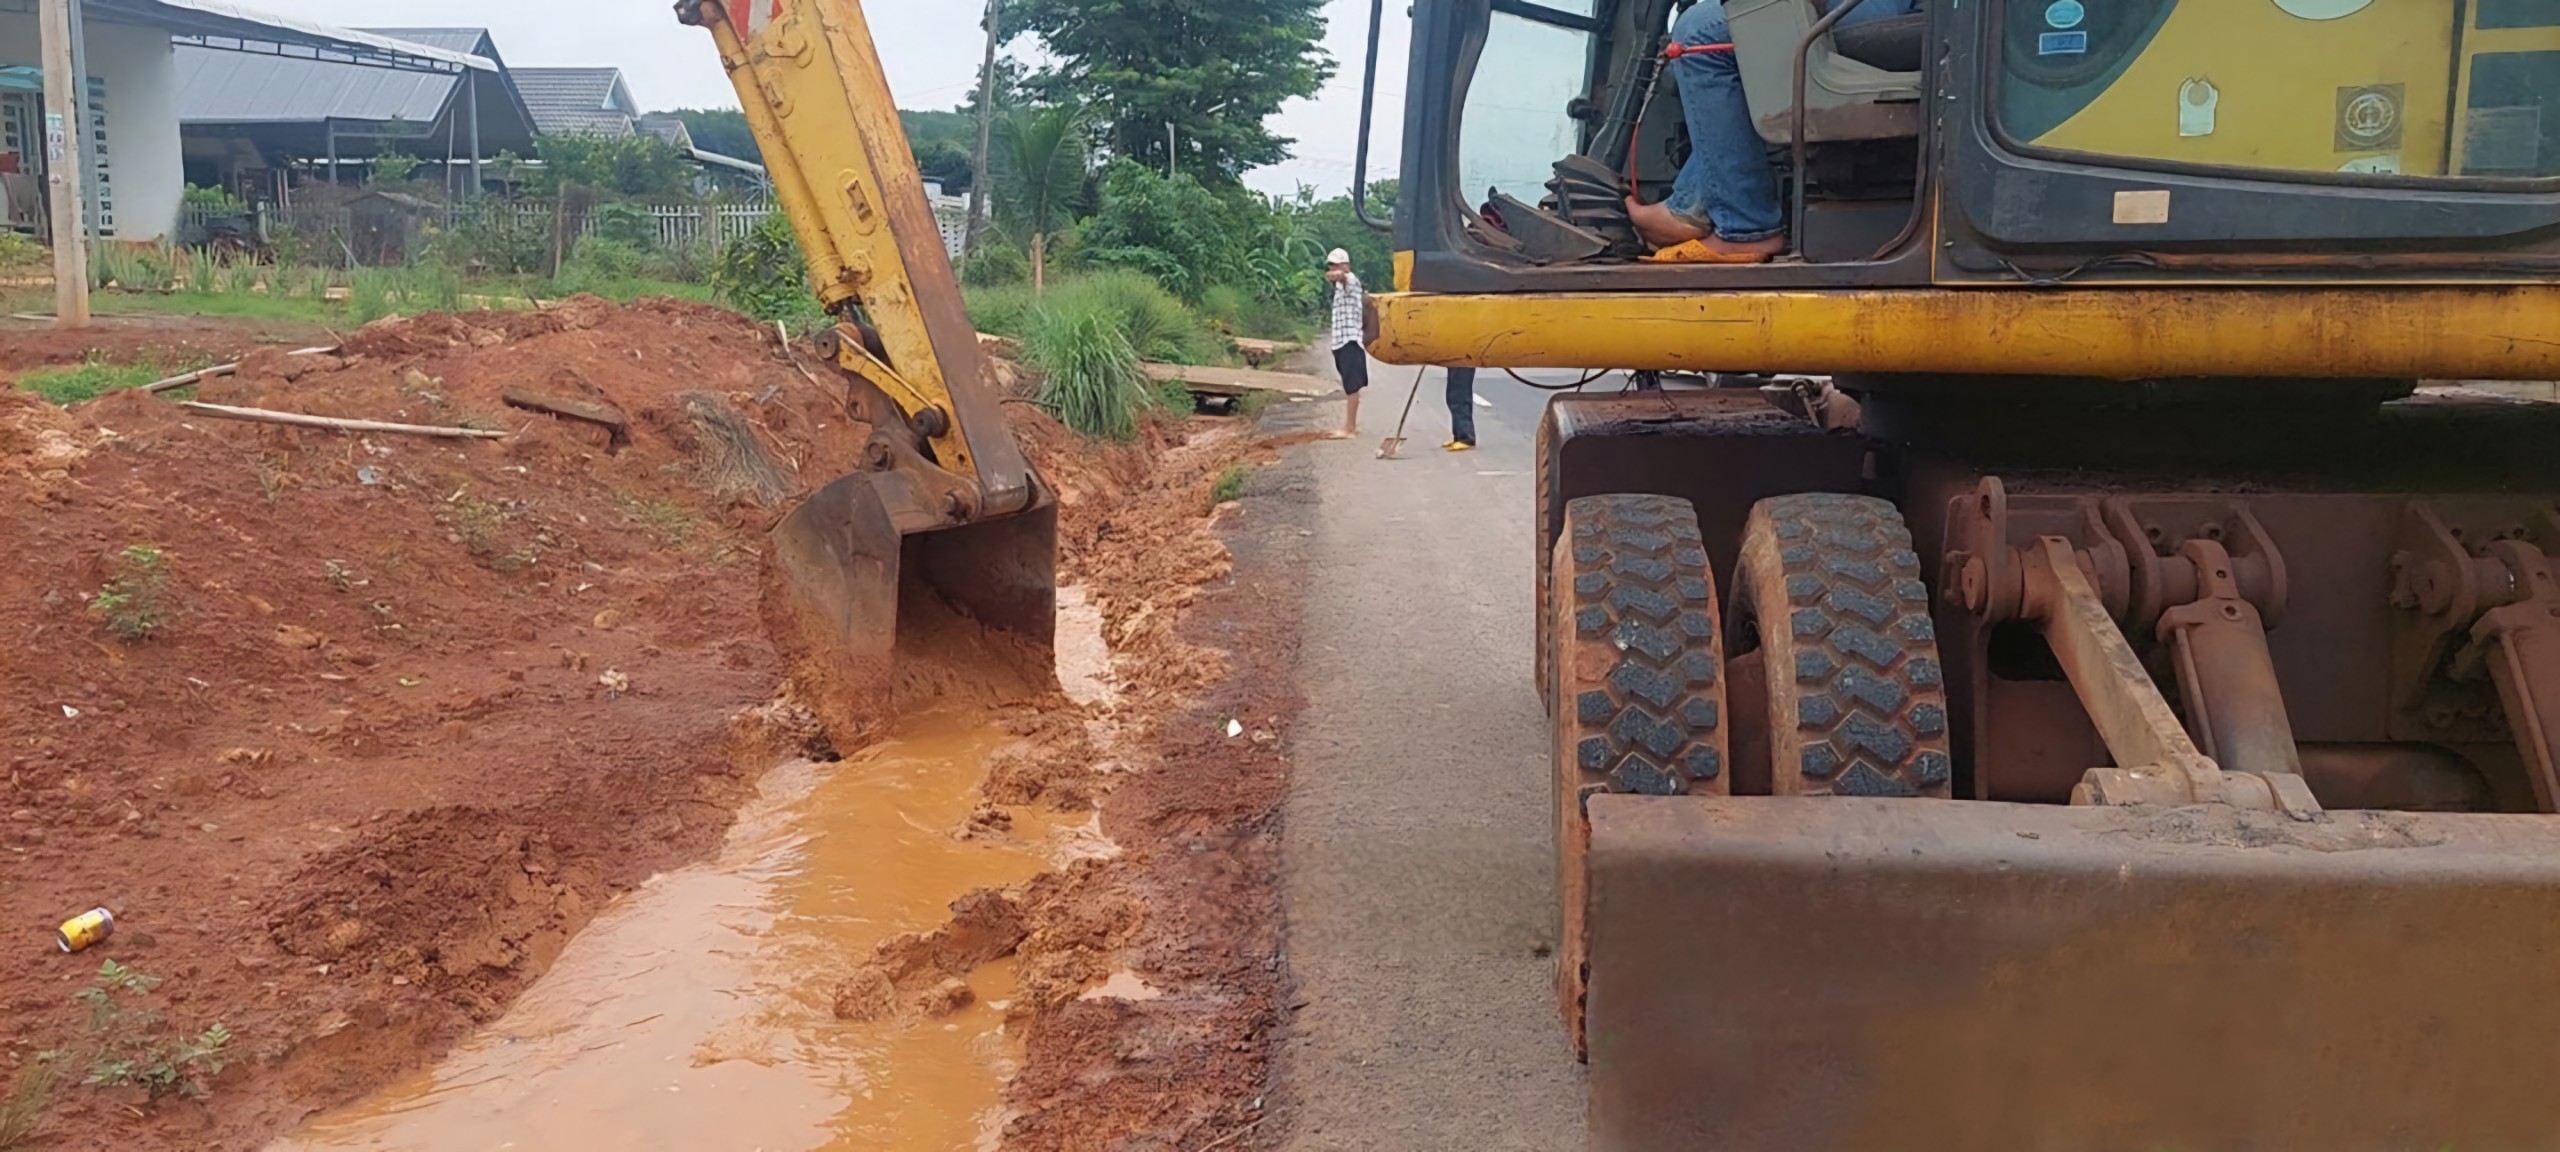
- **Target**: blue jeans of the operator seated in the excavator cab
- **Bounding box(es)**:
[1667,0,1920,243]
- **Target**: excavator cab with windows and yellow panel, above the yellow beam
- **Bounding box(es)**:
[1398,0,2560,276]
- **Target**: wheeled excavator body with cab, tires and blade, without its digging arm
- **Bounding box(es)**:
[1362,0,2560,1152]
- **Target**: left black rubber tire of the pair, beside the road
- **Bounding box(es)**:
[1539,494,1731,1060]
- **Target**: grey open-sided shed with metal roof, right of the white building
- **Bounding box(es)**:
[177,28,535,197]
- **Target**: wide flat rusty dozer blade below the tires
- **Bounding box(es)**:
[1590,796,2560,1152]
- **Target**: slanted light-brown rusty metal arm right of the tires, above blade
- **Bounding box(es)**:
[2020,538,2319,819]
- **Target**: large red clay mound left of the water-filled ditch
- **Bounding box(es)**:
[0,300,868,1152]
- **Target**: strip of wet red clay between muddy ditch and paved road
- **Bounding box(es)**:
[837,409,1298,1152]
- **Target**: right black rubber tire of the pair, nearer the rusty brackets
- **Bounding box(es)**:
[1733,492,1956,799]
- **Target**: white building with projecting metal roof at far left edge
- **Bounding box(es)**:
[0,0,499,241]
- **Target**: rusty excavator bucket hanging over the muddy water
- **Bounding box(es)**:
[763,474,1057,750]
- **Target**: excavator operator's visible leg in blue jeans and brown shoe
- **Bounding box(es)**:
[1626,0,1920,264]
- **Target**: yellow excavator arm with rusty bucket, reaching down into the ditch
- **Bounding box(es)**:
[676,0,1057,748]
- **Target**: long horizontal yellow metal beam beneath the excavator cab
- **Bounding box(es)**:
[1370,284,2560,379]
